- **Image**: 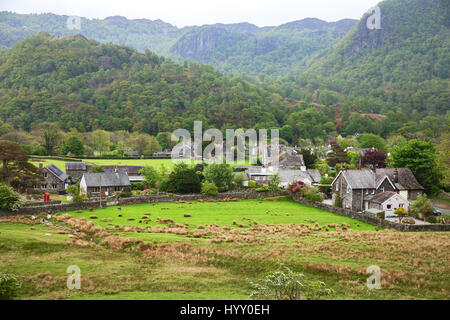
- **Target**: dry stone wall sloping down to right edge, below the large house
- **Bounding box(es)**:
[292,196,450,232]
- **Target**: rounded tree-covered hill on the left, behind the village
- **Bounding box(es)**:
[0,34,294,134]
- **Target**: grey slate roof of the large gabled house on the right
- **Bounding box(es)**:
[333,168,424,190]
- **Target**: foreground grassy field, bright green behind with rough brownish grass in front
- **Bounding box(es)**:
[0,198,450,300]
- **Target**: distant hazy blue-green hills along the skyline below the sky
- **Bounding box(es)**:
[0,12,357,75]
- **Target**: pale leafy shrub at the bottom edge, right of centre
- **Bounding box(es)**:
[249,267,334,300]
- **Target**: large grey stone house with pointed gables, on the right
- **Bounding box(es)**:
[331,168,424,211]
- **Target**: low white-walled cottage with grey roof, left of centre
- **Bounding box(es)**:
[80,172,131,196]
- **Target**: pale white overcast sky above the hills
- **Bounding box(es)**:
[0,0,380,27]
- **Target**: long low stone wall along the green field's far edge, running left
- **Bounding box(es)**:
[0,191,289,217]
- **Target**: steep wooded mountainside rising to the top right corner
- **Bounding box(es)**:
[278,0,450,130]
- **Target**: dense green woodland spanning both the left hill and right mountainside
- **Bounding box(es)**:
[0,0,450,145]
